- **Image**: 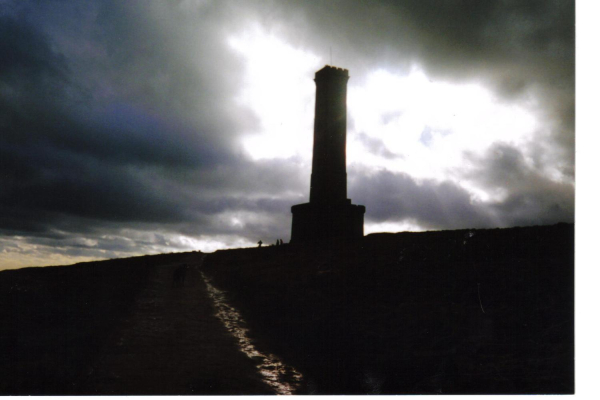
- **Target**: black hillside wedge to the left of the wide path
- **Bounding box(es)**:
[0,257,155,394]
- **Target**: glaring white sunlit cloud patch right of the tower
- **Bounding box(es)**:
[348,68,537,185]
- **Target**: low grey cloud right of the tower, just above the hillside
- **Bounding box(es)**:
[349,150,574,230]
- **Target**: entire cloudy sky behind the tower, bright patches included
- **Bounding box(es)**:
[0,0,575,268]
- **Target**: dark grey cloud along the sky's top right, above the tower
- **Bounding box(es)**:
[276,0,575,82]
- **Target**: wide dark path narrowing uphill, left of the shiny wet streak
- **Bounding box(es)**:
[88,258,273,395]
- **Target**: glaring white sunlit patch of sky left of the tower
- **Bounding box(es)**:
[229,26,321,160]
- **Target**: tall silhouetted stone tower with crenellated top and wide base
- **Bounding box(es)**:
[291,65,365,243]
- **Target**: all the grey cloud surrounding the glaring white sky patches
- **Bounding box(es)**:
[0,0,574,267]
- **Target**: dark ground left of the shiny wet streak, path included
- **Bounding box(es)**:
[0,252,272,395]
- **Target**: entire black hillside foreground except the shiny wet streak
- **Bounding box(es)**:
[0,224,574,394]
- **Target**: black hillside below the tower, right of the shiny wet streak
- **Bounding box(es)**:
[205,224,574,394]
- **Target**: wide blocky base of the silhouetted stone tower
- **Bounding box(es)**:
[290,199,365,244]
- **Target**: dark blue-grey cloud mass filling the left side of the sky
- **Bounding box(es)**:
[0,2,294,251]
